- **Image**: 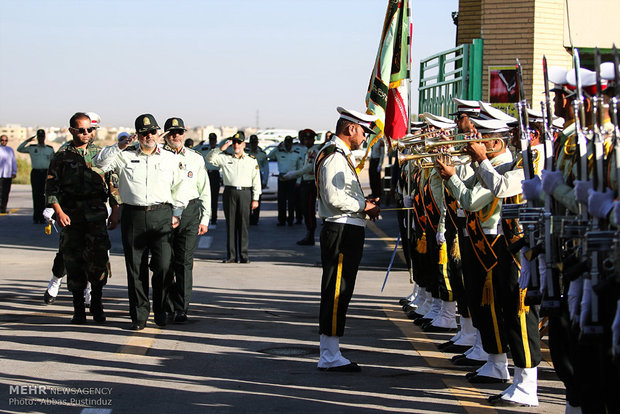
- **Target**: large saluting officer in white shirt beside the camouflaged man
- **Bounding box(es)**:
[95,114,185,330]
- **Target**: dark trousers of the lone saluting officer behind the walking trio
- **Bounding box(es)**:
[223,186,252,260]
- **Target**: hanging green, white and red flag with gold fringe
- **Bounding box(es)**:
[358,0,411,170]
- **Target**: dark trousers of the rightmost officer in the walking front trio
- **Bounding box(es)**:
[166,198,200,312]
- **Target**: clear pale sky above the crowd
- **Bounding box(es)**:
[0,0,458,130]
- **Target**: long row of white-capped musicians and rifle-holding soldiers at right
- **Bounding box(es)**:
[398,64,620,413]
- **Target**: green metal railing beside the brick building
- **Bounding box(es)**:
[418,39,482,116]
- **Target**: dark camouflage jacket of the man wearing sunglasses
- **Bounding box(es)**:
[45,142,121,221]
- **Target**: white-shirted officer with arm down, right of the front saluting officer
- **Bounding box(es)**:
[164,118,211,323]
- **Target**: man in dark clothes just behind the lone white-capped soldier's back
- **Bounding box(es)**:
[283,129,321,246]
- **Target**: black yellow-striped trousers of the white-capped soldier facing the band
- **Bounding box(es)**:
[319,221,365,336]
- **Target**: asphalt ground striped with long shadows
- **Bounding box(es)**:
[0,185,564,413]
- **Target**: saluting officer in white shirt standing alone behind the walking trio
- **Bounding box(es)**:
[206,132,262,263]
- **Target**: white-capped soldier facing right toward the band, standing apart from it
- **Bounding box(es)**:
[314,107,379,372]
